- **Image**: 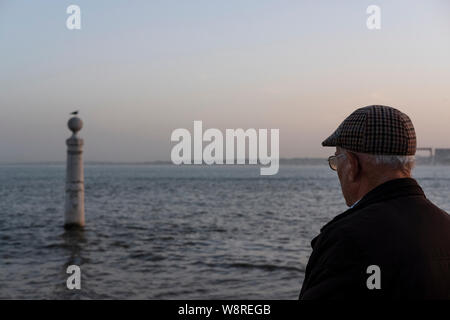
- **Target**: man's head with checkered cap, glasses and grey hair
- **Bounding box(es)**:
[322,105,416,206]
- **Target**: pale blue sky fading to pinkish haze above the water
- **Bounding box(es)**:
[0,0,450,162]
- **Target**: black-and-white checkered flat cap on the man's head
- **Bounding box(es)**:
[322,105,416,155]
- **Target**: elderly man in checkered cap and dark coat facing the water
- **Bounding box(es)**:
[299,105,450,299]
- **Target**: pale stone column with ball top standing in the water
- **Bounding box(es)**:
[64,117,84,227]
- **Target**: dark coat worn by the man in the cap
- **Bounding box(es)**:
[299,178,450,299]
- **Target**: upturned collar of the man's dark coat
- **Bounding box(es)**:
[320,178,425,232]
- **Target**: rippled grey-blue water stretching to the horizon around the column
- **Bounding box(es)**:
[0,165,450,299]
